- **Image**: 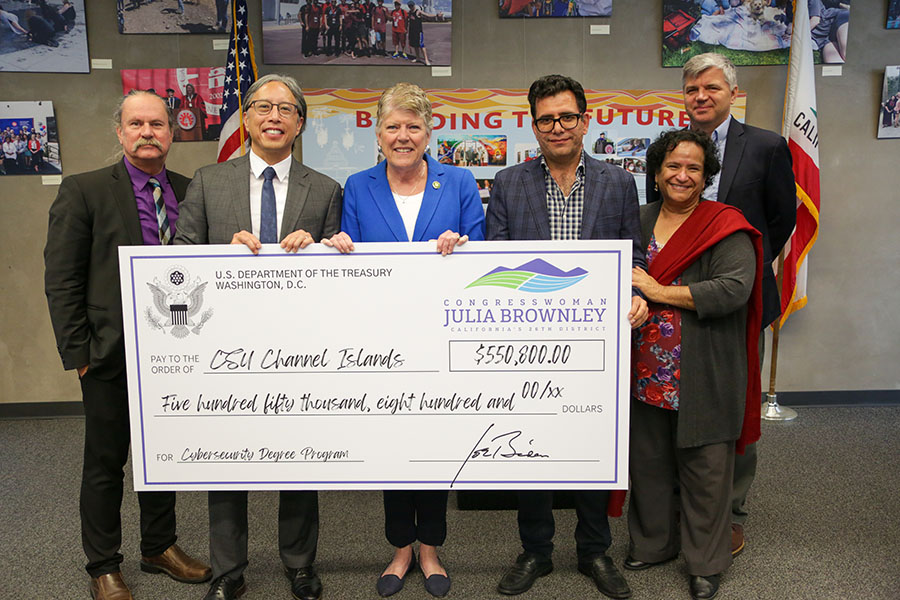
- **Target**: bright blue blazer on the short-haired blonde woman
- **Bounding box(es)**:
[341,154,484,242]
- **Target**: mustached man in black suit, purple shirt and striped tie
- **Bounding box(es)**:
[44,90,210,600]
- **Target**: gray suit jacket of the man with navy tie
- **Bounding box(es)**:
[175,155,341,244]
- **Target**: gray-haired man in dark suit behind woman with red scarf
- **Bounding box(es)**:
[648,52,797,566]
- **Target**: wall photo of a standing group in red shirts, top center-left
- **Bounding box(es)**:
[263,0,452,66]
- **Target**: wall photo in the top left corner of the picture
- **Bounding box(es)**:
[0,0,90,73]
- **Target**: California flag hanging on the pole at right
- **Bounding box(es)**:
[780,0,819,325]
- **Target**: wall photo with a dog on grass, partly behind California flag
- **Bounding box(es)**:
[663,0,851,67]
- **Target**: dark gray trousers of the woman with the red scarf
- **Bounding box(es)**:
[628,400,734,576]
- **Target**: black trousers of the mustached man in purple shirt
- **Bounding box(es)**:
[80,370,176,577]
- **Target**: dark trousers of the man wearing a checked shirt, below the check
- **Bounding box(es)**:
[518,490,612,562]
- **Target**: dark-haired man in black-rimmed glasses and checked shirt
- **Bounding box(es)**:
[486,75,647,598]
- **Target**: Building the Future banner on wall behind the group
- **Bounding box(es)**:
[303,88,747,203]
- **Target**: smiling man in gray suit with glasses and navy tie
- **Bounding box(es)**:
[175,74,341,600]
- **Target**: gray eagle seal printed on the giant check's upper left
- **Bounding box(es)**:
[145,265,213,338]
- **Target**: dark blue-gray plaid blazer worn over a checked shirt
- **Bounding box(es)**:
[485,151,647,269]
